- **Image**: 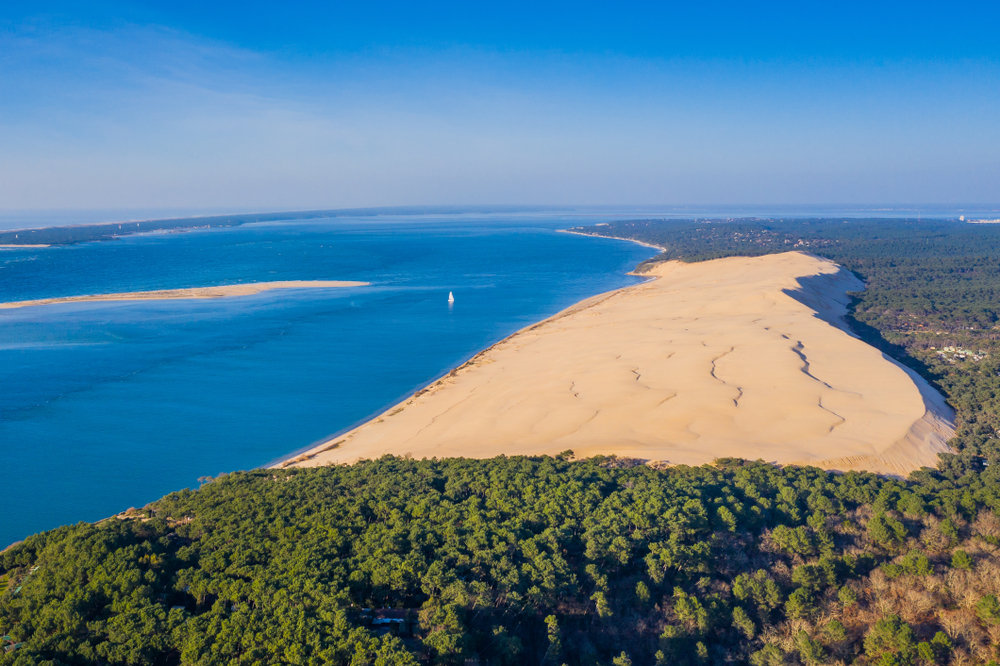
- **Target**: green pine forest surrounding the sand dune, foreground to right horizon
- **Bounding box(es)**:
[0,215,1000,666]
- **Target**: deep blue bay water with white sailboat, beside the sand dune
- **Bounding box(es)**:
[0,216,654,547]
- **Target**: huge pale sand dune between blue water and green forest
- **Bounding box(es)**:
[284,252,953,475]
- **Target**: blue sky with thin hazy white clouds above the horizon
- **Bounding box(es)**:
[0,0,1000,210]
